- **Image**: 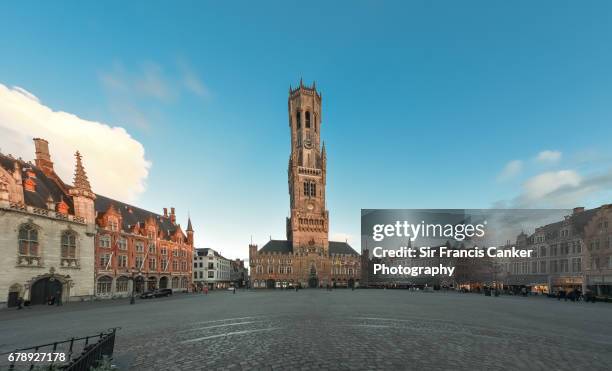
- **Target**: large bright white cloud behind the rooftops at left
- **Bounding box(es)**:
[0,84,151,201]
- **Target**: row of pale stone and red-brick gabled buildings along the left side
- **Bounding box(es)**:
[0,138,204,307]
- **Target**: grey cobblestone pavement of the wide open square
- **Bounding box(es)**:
[0,290,612,370]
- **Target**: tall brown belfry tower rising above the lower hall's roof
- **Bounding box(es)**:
[287,80,329,255]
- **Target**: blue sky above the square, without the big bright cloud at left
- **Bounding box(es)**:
[0,1,612,257]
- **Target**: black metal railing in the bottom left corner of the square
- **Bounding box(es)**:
[0,327,120,371]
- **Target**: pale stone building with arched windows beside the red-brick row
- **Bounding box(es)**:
[0,139,95,307]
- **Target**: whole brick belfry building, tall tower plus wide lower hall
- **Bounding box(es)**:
[249,81,360,288]
